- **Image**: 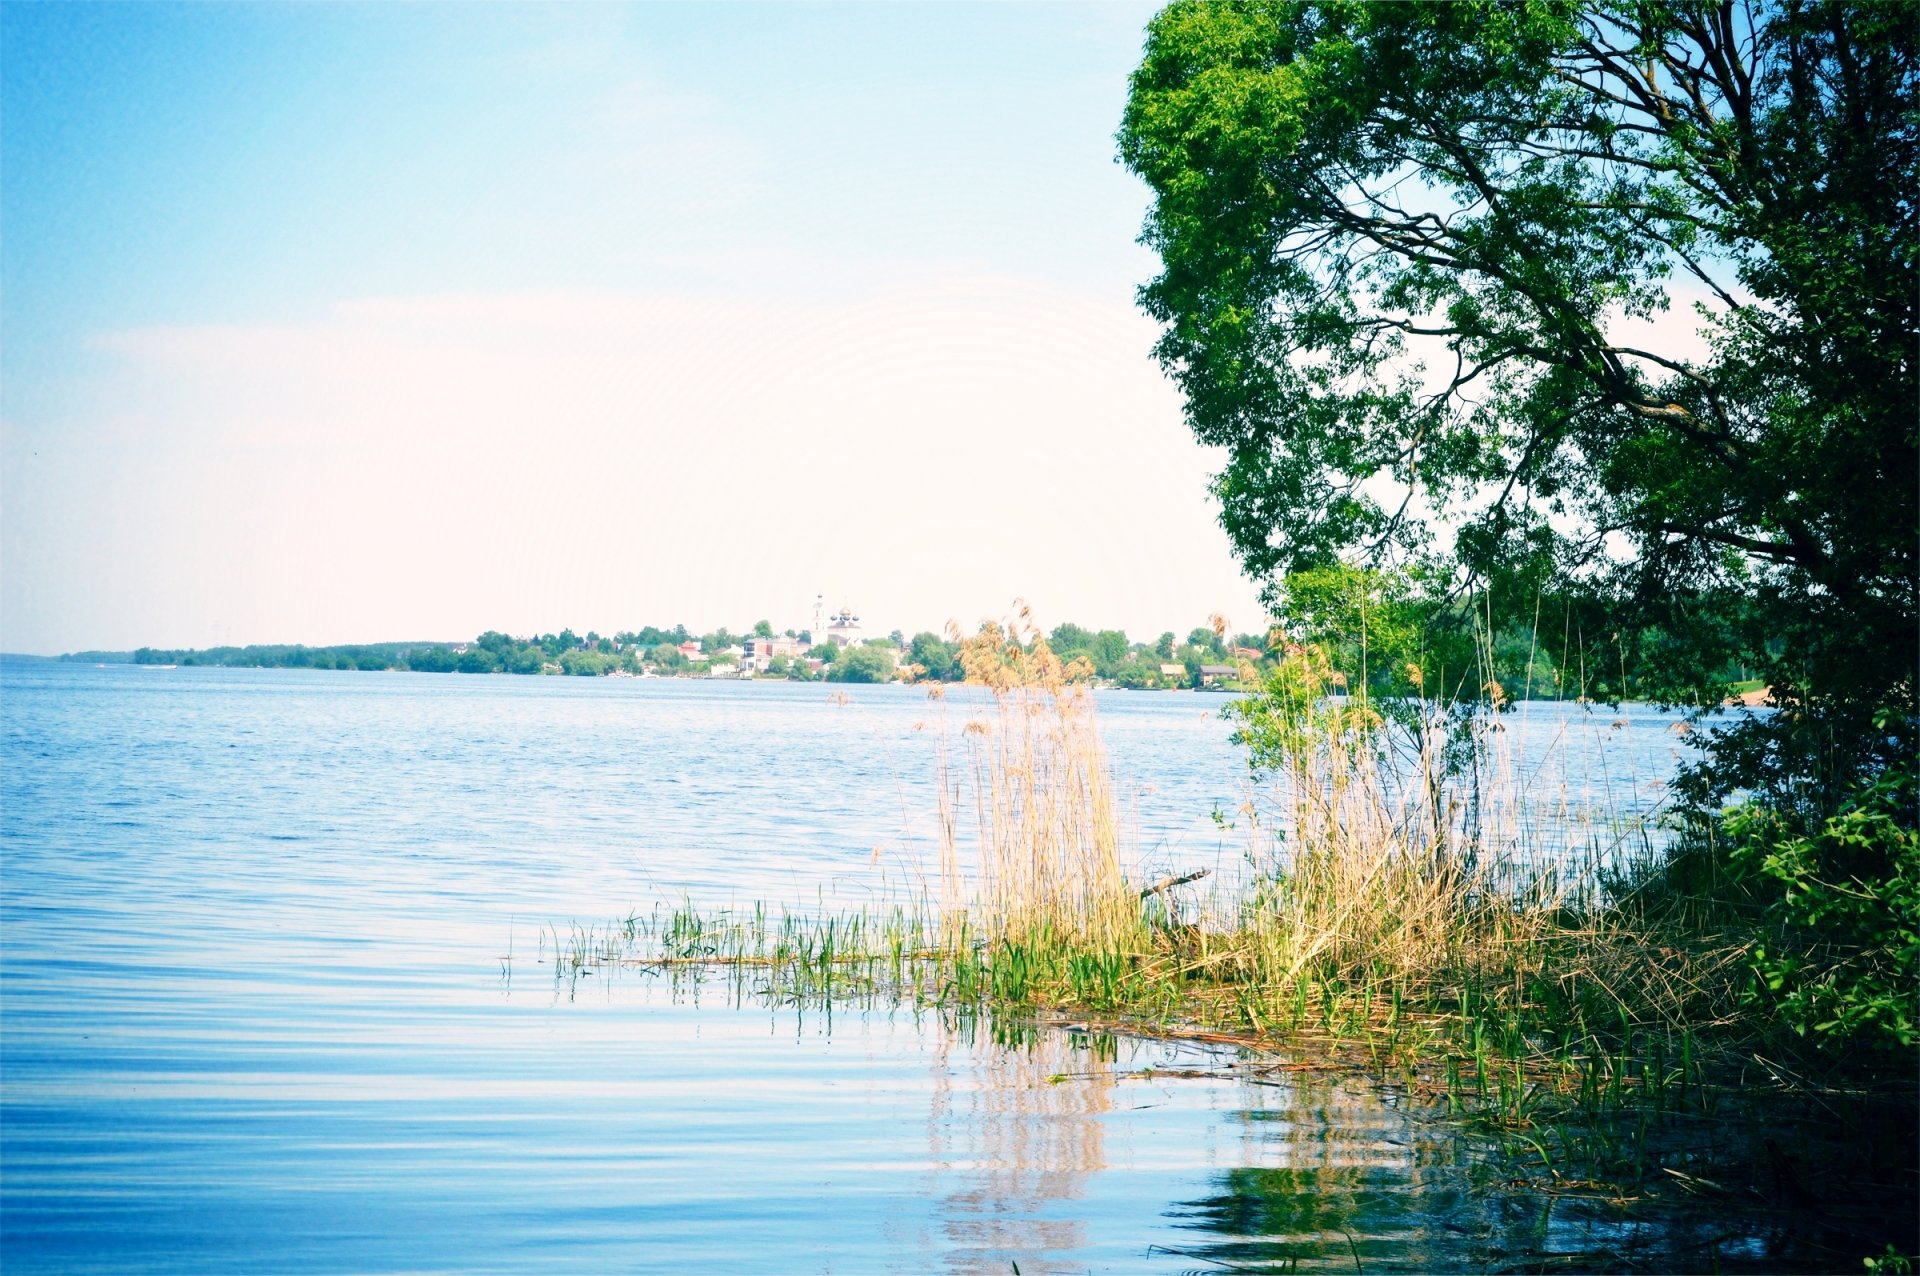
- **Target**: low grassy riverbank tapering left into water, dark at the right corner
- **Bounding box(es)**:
[560,882,1916,1272]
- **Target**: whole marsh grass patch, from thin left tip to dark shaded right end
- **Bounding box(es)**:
[541,616,1910,1243]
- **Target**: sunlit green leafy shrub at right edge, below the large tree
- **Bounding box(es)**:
[1726,768,1920,1046]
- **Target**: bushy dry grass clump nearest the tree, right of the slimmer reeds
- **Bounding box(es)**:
[1213,647,1743,1053]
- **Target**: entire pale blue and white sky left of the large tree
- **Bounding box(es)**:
[0,4,1290,654]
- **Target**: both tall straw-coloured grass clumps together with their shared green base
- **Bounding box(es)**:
[913,612,1766,1120]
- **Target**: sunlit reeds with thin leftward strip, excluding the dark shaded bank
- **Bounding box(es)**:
[547,633,1724,1089]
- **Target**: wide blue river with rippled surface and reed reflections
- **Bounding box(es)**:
[0,660,1728,1274]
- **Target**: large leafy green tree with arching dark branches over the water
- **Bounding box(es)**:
[1119,0,1920,817]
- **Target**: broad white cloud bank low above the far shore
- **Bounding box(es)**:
[6,274,1258,645]
